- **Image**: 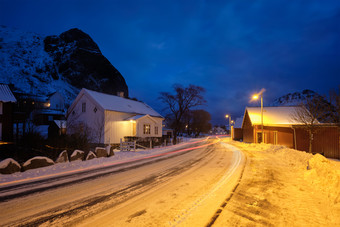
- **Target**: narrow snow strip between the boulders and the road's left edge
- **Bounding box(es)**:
[0,138,205,187]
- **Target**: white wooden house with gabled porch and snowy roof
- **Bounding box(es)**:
[67,88,164,144]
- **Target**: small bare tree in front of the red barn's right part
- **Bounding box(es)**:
[291,96,328,153]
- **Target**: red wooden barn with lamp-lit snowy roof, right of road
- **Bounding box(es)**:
[242,107,340,159]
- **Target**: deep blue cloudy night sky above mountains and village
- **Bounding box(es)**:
[0,0,340,124]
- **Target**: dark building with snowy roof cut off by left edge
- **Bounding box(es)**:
[0,84,17,142]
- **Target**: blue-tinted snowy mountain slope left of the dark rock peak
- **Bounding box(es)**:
[0,26,79,103]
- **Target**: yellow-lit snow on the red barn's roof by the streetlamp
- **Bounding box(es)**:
[246,106,303,125]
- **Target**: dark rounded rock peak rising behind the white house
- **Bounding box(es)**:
[44,28,129,97]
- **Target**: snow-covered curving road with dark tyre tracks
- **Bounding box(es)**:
[0,139,244,226]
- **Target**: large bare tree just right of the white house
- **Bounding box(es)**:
[159,84,206,143]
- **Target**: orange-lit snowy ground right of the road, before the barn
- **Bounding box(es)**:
[215,141,340,226]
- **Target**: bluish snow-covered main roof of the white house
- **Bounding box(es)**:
[83,88,163,118]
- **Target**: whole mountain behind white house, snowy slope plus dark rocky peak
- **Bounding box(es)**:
[0,26,128,104]
